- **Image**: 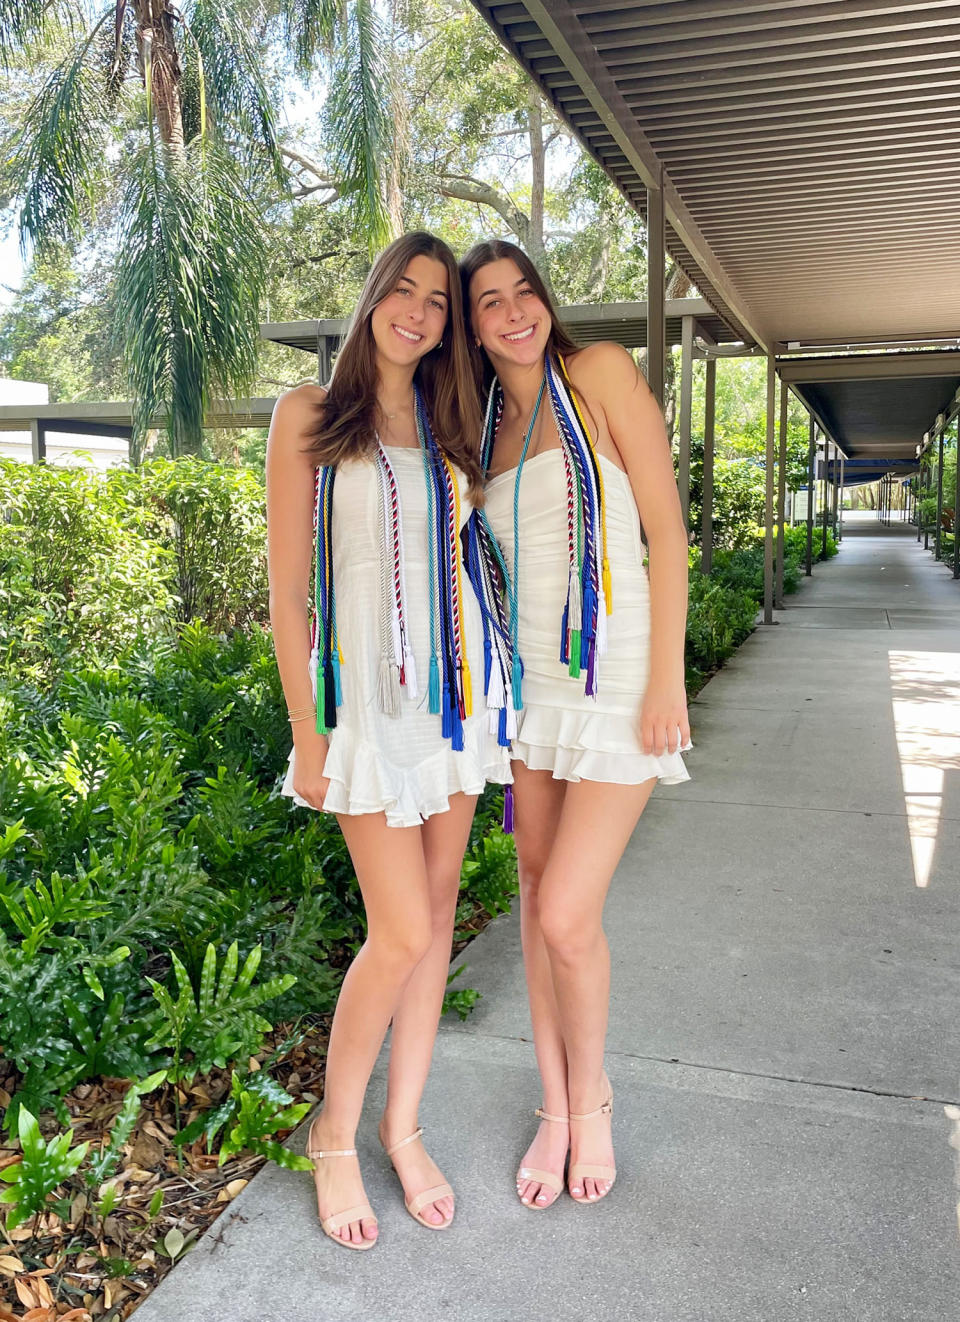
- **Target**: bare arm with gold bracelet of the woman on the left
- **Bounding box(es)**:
[267,387,327,808]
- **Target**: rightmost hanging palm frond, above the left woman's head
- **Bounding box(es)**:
[325,0,394,251]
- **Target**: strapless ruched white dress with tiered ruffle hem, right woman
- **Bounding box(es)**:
[487,448,690,785]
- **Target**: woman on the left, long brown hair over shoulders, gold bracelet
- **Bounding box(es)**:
[267,233,509,1249]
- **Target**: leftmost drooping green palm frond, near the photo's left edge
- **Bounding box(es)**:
[11,7,115,251]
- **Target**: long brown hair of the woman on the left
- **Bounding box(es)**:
[307,230,483,504]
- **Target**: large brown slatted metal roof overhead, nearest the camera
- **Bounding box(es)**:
[473,0,960,350]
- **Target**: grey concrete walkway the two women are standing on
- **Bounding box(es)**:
[138,524,960,1322]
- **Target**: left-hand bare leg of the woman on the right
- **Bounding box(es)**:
[513,760,570,1207]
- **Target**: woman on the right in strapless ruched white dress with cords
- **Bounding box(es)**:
[460,242,689,1208]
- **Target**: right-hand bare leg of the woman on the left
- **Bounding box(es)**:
[380,795,476,1225]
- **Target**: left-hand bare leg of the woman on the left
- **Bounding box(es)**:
[313,813,431,1243]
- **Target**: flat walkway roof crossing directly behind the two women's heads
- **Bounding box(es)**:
[260,299,738,353]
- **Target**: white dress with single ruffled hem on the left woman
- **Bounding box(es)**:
[282,446,512,826]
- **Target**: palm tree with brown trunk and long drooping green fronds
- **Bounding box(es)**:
[0,0,393,459]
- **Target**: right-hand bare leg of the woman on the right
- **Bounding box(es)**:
[540,780,656,1200]
